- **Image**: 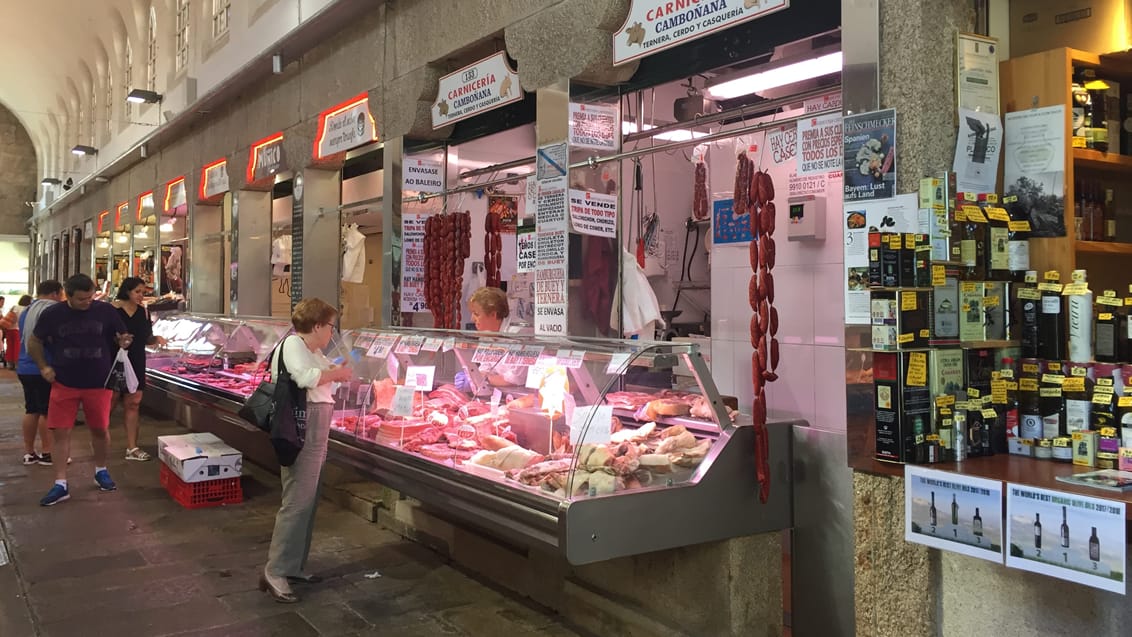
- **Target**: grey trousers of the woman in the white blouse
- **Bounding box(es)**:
[266,403,334,577]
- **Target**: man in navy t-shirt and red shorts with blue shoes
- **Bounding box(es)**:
[27,274,134,507]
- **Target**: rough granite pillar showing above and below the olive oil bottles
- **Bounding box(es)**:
[854,0,975,637]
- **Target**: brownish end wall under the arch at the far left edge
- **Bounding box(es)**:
[0,105,38,235]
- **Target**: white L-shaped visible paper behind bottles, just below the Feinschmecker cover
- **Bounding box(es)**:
[842,193,920,325]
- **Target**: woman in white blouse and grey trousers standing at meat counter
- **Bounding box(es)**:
[259,299,351,604]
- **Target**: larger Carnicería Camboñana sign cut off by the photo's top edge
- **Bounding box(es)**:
[614,0,790,64]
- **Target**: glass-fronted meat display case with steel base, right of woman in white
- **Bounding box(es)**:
[331,329,794,563]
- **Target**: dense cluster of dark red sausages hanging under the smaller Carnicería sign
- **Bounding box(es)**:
[425,212,472,329]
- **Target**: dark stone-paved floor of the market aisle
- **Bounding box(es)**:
[0,371,576,637]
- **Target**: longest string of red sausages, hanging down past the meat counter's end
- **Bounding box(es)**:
[735,153,779,502]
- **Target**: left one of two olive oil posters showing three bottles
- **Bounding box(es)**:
[904,465,1003,563]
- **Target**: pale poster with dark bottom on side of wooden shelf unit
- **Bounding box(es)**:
[1003,104,1066,236]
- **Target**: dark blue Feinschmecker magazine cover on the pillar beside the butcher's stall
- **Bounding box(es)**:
[841,109,897,204]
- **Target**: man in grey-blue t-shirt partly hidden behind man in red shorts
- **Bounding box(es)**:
[16,279,63,465]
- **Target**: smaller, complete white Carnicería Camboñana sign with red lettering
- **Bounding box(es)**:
[432,51,523,129]
